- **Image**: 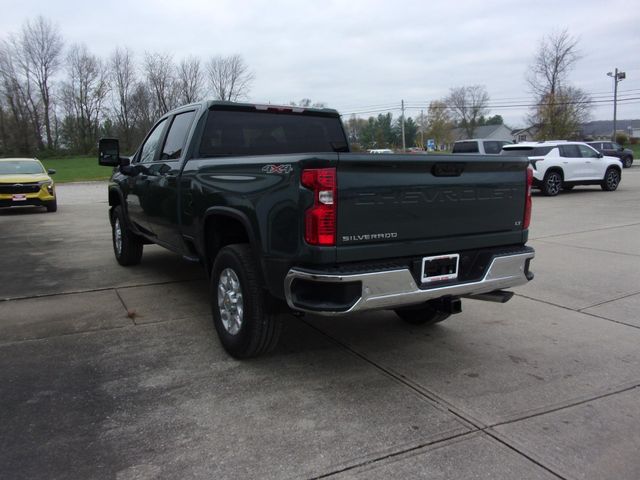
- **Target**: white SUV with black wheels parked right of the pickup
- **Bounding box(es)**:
[502,140,622,196]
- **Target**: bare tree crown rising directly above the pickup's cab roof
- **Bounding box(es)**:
[207,55,254,102]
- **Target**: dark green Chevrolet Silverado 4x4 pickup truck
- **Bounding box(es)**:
[99,102,534,358]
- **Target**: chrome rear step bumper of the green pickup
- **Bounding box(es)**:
[284,248,535,315]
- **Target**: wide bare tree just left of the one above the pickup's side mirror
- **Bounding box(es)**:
[62,45,109,153]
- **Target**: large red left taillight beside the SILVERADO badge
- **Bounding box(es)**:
[300,168,338,245]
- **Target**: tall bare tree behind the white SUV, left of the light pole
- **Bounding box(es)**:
[527,30,591,139]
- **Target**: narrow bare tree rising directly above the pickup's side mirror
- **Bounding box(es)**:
[109,48,136,151]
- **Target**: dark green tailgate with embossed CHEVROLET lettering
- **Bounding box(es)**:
[337,154,527,261]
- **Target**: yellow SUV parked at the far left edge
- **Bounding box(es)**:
[0,158,58,212]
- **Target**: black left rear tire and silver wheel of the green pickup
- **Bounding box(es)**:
[210,243,282,358]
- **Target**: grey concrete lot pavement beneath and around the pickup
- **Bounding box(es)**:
[0,170,640,480]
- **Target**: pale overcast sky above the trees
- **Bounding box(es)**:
[0,0,640,127]
